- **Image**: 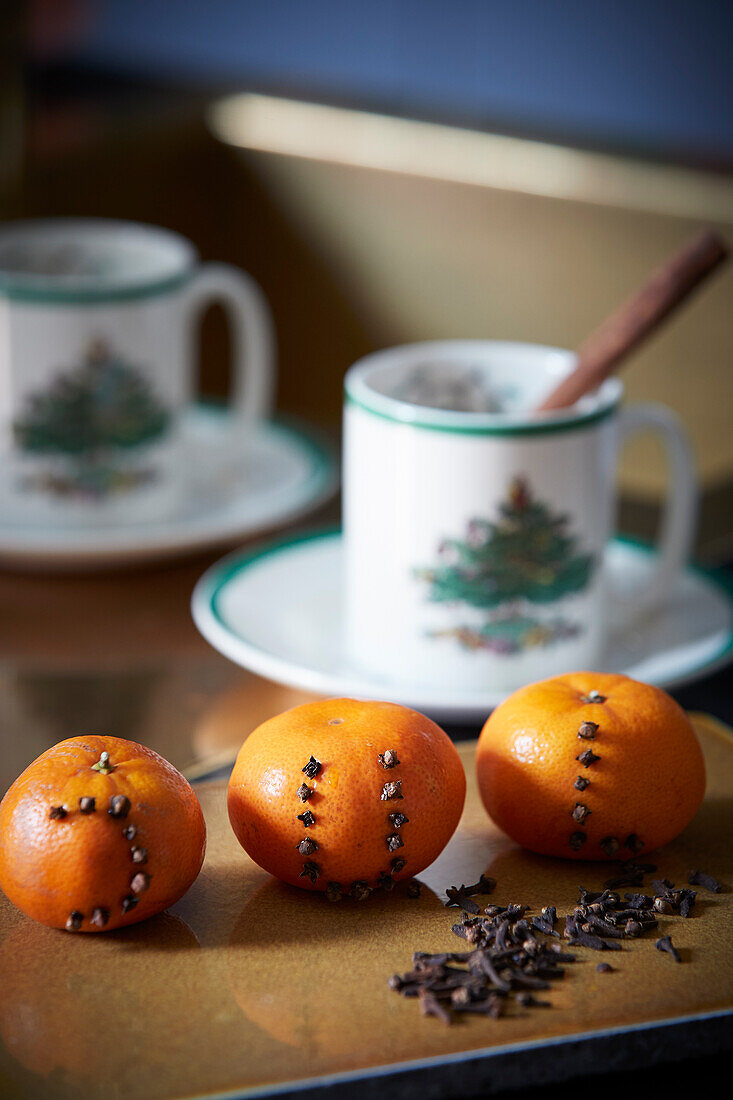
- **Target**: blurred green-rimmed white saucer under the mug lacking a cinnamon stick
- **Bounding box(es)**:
[0,405,338,570]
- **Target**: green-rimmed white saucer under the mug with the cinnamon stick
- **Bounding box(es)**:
[192,531,733,723]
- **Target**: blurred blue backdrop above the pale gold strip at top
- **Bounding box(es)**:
[71,0,733,160]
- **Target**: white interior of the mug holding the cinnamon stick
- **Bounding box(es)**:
[346,340,623,430]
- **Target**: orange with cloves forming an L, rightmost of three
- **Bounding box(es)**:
[477,672,705,859]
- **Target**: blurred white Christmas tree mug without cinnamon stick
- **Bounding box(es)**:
[0,219,274,526]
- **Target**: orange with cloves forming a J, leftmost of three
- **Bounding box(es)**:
[0,736,206,932]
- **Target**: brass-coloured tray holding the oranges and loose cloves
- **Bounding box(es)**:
[0,716,733,1100]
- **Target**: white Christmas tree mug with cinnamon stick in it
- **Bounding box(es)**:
[343,340,697,691]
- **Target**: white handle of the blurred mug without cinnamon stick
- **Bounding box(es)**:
[182,264,276,424]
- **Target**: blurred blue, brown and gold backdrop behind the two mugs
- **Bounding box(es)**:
[0,0,733,550]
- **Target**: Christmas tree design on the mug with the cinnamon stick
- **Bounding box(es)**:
[415,477,595,656]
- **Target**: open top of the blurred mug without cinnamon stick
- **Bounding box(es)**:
[0,218,196,297]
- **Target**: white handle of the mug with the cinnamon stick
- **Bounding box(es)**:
[617,404,698,609]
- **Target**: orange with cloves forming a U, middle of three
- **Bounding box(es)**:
[229,699,466,900]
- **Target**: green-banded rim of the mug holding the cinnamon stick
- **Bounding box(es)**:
[343,340,623,436]
